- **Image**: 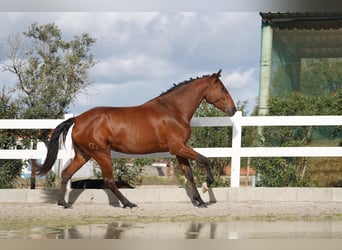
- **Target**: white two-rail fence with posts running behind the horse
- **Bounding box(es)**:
[0,112,342,187]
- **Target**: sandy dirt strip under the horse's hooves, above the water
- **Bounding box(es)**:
[0,202,342,226]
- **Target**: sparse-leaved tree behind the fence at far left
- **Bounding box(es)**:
[2,23,95,188]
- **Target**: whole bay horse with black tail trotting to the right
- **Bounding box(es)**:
[36,70,236,208]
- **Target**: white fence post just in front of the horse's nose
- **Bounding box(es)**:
[230,111,242,187]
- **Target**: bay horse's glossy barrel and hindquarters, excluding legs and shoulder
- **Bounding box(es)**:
[73,105,171,153]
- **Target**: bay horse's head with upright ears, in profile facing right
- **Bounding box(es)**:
[204,70,236,116]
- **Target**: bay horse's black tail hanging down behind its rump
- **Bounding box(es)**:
[36,117,75,176]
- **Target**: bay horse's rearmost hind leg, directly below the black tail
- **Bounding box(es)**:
[57,150,90,208]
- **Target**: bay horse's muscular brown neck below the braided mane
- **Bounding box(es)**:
[160,79,207,121]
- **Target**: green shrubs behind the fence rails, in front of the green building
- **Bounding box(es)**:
[253,89,342,187]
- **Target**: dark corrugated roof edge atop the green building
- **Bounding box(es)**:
[260,12,342,29]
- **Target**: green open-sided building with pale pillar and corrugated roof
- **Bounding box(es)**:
[258,12,342,115]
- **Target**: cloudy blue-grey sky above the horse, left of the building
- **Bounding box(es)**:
[0,12,261,114]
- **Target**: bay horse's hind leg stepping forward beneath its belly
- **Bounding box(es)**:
[92,151,137,208]
